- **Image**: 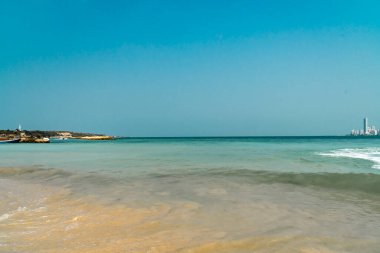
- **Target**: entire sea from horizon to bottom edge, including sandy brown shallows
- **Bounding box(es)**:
[0,137,380,253]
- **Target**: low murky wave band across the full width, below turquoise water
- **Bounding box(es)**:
[0,164,380,198]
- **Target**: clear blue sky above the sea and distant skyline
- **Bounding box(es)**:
[0,0,380,136]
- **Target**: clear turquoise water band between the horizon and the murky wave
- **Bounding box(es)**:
[0,137,380,174]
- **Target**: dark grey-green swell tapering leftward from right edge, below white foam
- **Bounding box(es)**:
[150,169,380,194]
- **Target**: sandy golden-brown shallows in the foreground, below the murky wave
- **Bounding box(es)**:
[0,168,380,253]
